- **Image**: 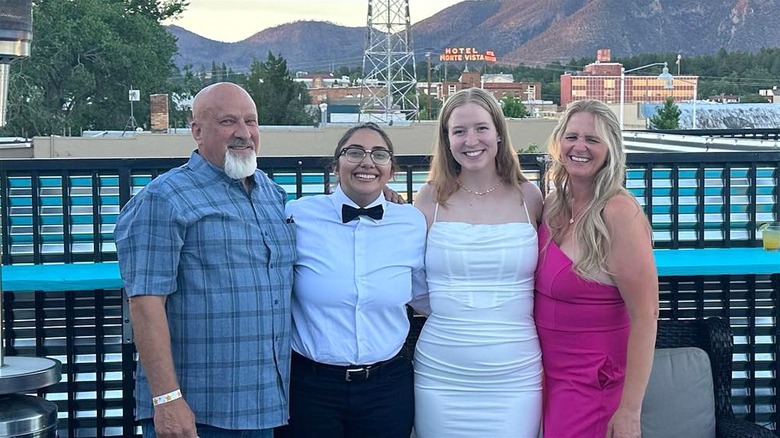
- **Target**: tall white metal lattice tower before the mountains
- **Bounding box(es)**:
[360,0,420,124]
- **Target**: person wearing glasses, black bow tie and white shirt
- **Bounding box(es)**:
[284,123,426,438]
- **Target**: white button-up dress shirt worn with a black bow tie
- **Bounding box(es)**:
[286,188,427,365]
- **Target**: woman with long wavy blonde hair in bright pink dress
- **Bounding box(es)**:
[534,100,658,438]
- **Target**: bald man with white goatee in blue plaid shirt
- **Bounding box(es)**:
[115,83,295,438]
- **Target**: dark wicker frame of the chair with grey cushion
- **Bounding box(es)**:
[655,318,775,438]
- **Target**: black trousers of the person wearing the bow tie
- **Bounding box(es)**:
[275,352,414,438]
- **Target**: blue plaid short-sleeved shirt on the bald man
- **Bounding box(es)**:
[115,152,295,430]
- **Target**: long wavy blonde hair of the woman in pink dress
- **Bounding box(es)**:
[544,100,638,280]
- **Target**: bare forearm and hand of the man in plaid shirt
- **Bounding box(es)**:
[130,295,197,438]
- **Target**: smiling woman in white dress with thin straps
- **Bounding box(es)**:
[414,88,542,438]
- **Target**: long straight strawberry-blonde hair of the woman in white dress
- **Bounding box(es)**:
[428,88,528,205]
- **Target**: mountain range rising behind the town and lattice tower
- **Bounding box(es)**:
[169,0,780,71]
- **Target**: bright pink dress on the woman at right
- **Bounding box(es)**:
[534,225,629,438]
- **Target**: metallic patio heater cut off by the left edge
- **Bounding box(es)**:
[0,0,61,438]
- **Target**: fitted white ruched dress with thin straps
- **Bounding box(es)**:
[414,222,542,438]
